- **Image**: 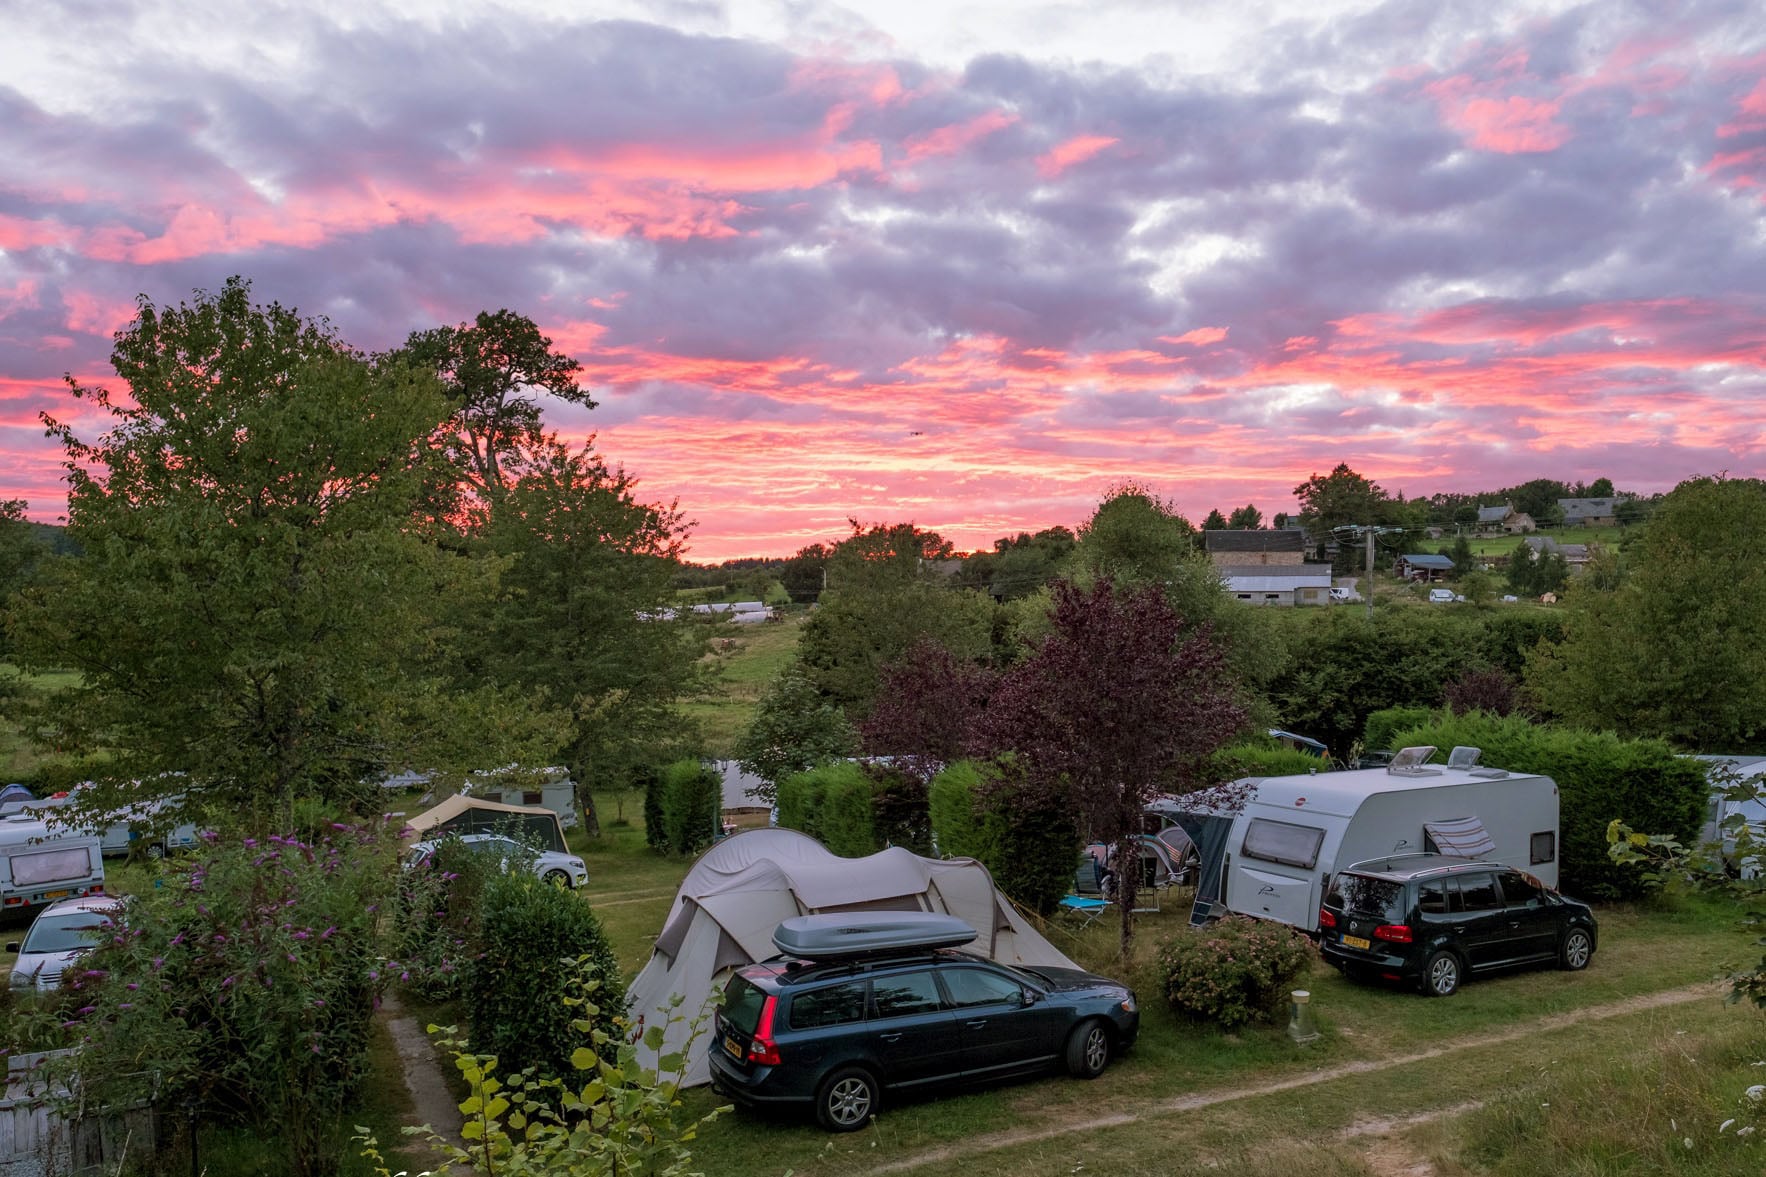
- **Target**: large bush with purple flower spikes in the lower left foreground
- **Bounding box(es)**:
[69,825,399,1177]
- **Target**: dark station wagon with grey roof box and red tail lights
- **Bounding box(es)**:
[710,912,1141,1133]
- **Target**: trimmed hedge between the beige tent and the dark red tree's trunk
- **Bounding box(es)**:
[927,760,1079,915]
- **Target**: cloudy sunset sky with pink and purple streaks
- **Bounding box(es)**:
[0,0,1766,560]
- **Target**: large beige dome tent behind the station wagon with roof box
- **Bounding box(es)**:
[625,829,1077,1085]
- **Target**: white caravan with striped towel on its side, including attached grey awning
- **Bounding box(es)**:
[1155,748,1558,931]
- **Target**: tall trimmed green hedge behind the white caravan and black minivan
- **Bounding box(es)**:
[1395,712,1709,900]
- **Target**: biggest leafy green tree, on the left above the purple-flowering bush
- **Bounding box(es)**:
[18,279,561,822]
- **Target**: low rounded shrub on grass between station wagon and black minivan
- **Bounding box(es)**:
[1157,915,1314,1030]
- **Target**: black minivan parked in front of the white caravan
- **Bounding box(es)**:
[1319,854,1598,997]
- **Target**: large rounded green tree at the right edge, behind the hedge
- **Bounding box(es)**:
[1528,477,1766,753]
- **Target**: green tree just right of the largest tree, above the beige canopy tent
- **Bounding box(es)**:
[477,438,705,825]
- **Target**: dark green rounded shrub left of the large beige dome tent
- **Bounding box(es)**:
[466,871,625,1078]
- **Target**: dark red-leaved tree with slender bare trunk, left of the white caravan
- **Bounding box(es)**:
[971,580,1245,960]
